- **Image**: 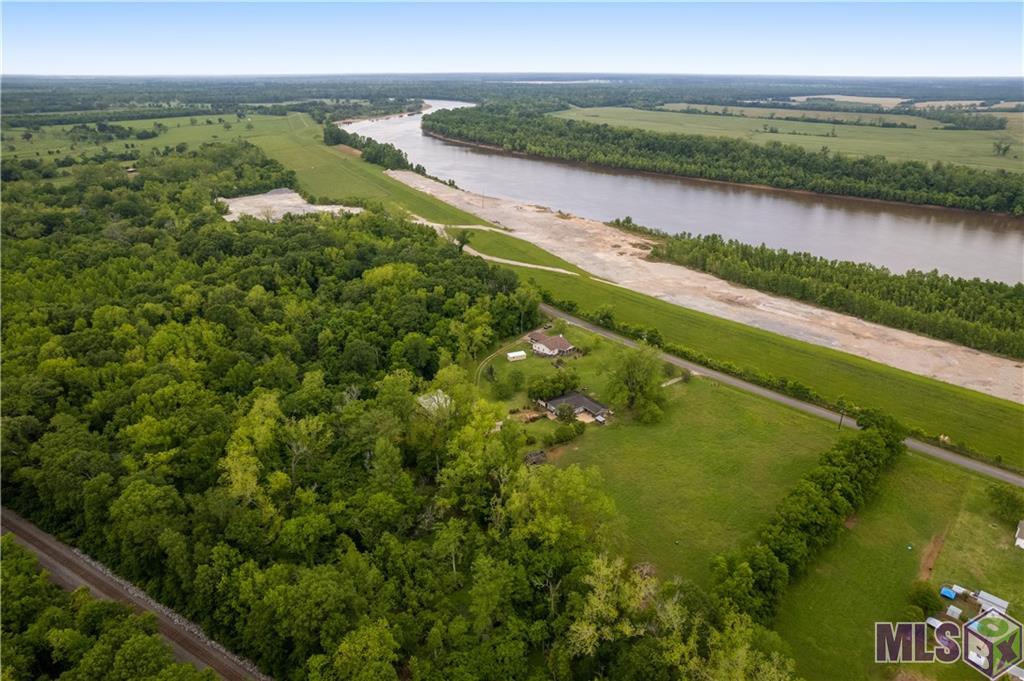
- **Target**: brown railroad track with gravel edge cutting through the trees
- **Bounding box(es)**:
[0,508,269,681]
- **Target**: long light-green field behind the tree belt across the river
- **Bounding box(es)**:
[552,107,1024,171]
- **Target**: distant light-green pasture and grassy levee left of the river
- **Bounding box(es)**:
[3,113,480,224]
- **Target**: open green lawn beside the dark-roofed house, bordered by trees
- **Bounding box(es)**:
[557,378,839,584]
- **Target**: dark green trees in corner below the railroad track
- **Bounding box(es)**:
[0,535,217,681]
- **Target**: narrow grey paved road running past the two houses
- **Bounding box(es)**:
[541,303,1024,487]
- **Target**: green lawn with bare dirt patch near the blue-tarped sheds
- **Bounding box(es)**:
[774,455,1024,681]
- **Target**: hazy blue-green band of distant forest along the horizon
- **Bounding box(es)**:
[3,74,1021,114]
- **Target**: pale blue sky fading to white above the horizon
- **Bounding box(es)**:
[2,2,1024,76]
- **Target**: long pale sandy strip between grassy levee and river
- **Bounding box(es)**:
[388,171,1024,403]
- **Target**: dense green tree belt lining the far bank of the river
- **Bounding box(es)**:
[423,101,1024,215]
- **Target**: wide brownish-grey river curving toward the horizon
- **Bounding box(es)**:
[345,100,1024,283]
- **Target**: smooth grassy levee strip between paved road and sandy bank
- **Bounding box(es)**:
[491,260,1024,469]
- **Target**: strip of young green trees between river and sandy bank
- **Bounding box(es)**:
[611,217,1024,358]
